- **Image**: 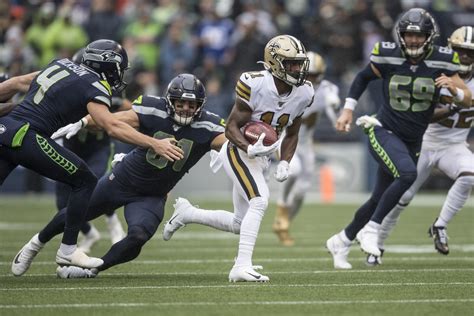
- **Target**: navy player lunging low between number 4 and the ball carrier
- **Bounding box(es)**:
[11,74,226,278]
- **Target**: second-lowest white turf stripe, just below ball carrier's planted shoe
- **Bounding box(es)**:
[0,282,474,292]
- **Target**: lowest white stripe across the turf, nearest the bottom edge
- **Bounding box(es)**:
[0,298,474,309]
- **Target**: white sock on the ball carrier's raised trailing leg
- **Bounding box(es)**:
[188,207,240,234]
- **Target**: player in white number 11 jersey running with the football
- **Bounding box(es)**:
[163,35,314,282]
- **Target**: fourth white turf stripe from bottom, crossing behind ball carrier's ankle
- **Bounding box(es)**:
[0,256,474,266]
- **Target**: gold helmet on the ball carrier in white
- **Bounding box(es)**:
[264,35,309,86]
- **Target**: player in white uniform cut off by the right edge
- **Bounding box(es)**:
[367,26,474,265]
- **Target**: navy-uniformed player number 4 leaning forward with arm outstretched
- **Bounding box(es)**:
[9,40,183,276]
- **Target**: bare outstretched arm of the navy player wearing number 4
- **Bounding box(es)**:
[87,102,183,161]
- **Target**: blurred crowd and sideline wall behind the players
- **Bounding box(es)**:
[0,0,474,199]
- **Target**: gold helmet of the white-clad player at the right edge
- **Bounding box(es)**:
[448,26,474,74]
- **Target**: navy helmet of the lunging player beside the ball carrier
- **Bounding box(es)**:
[166,74,206,125]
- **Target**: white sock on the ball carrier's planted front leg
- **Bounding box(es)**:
[234,208,265,267]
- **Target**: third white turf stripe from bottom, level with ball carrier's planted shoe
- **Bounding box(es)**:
[0,268,474,278]
